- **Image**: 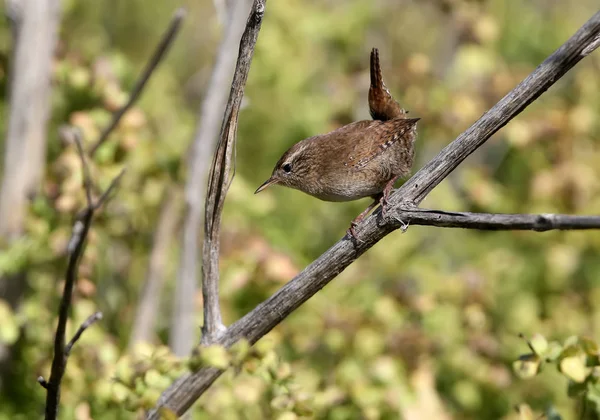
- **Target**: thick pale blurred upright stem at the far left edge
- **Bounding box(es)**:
[0,0,60,389]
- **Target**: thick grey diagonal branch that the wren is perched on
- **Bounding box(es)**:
[148,12,600,419]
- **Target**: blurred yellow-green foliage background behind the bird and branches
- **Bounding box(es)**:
[0,0,600,420]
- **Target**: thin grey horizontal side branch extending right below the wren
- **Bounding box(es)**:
[390,209,600,232]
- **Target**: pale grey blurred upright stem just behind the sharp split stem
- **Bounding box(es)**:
[170,0,250,356]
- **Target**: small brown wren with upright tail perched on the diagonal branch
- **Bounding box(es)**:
[255,48,419,239]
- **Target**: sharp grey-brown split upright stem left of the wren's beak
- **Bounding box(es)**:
[202,0,266,344]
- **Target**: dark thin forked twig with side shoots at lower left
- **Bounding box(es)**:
[43,129,123,420]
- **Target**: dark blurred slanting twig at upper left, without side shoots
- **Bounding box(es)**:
[89,8,186,156]
